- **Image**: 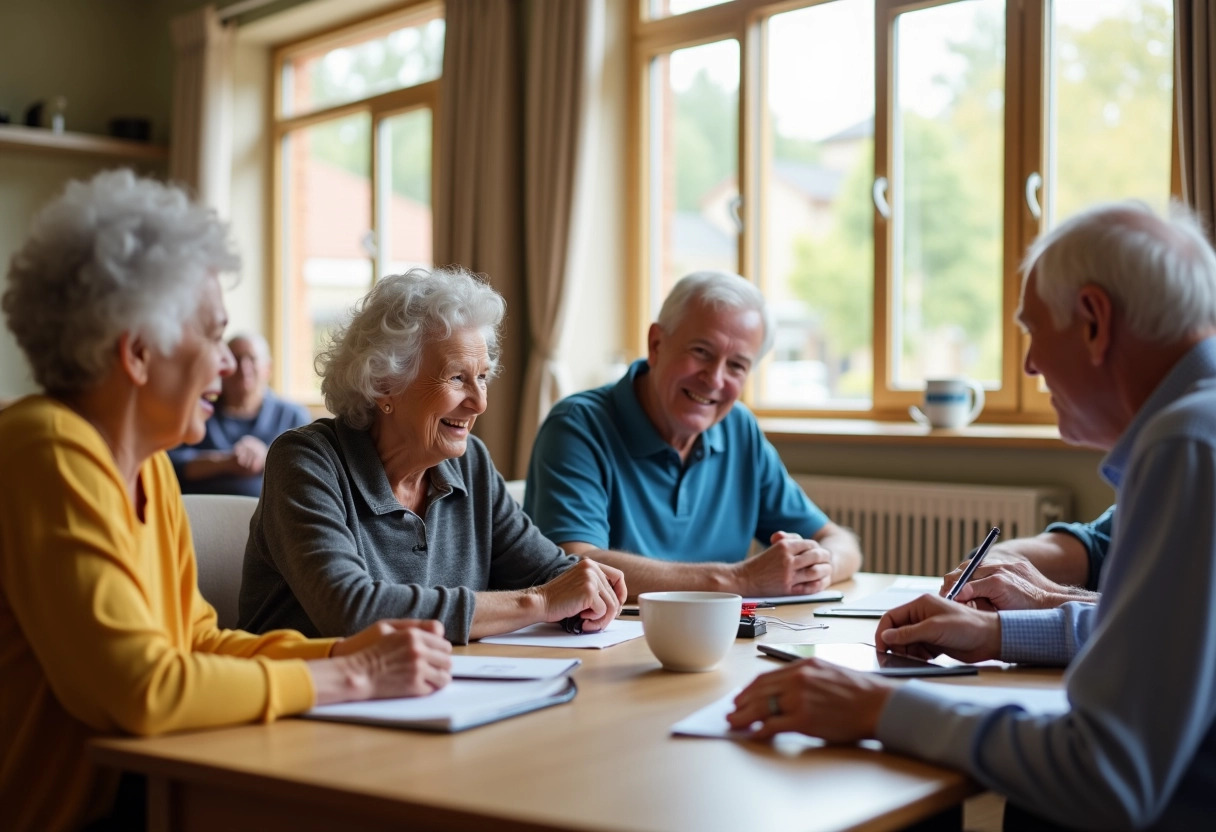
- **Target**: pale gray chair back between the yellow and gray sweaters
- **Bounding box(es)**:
[182,494,258,630]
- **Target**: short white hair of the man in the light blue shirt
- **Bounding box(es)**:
[1021,201,1216,343]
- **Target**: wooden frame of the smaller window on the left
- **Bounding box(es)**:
[269,0,444,405]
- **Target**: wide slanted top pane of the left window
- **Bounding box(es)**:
[282,15,444,116]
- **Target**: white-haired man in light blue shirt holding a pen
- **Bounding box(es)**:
[730,203,1216,830]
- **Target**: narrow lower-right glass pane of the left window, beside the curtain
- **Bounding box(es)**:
[377,108,432,275]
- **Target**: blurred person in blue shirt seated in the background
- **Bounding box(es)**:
[169,335,313,496]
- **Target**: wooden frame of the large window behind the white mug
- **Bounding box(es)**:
[625,0,1182,423]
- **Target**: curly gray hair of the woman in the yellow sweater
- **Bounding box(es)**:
[0,170,241,394]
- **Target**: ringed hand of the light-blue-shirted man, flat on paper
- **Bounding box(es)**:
[726,659,895,742]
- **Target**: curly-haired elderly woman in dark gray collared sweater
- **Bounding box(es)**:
[241,268,625,643]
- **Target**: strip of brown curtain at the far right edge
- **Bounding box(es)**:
[1173,0,1216,236]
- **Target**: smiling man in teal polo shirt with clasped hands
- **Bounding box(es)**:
[524,271,861,596]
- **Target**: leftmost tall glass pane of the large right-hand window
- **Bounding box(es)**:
[646,40,739,321]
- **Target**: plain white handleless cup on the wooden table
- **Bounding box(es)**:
[637,592,743,670]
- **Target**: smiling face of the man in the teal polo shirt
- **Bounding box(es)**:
[638,302,764,456]
